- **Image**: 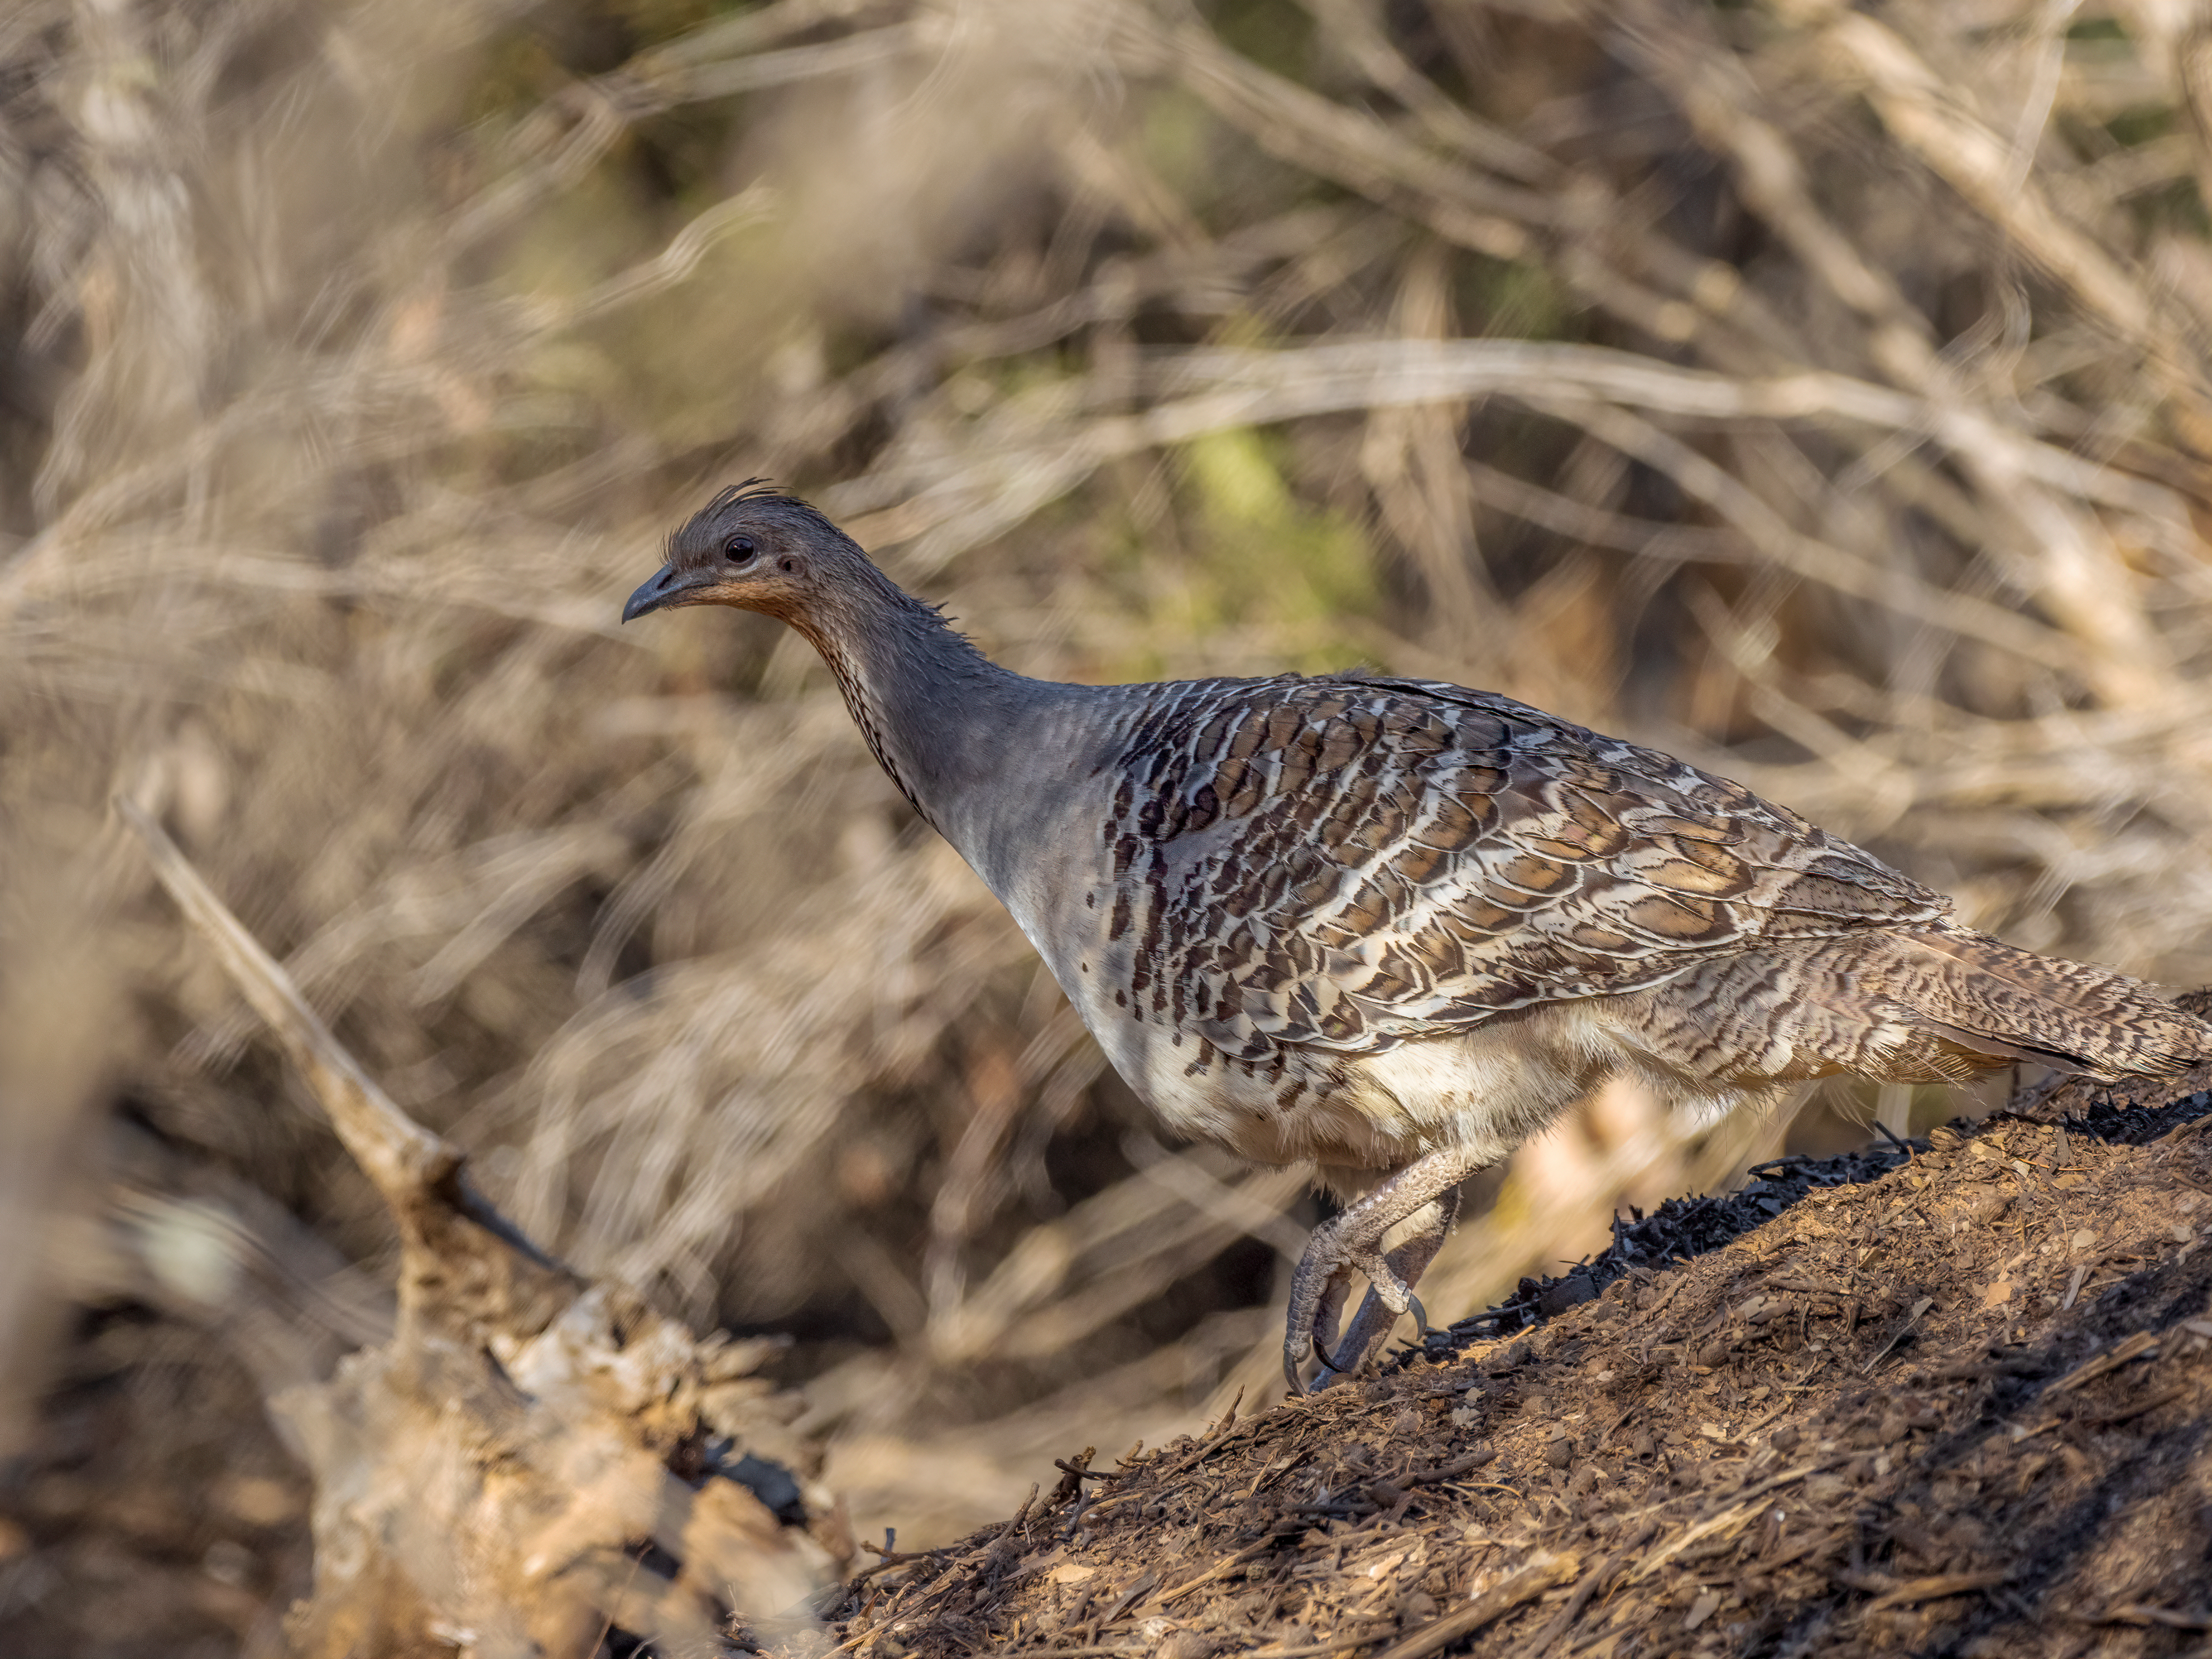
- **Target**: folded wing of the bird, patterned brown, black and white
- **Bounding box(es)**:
[1108,677,1951,1057]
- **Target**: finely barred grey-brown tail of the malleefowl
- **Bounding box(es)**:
[1878,925,2212,1082]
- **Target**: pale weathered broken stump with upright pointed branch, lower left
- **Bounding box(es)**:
[117,801,852,1659]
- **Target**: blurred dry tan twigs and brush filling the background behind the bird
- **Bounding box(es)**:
[13,0,2212,1655]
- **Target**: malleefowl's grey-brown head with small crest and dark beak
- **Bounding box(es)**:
[621,491,867,621]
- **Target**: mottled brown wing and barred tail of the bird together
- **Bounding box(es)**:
[1088,677,2201,1082]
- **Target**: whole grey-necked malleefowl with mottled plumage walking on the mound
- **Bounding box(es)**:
[624,489,2212,1389]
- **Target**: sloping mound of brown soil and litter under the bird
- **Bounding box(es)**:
[843,1044,2212,1659]
